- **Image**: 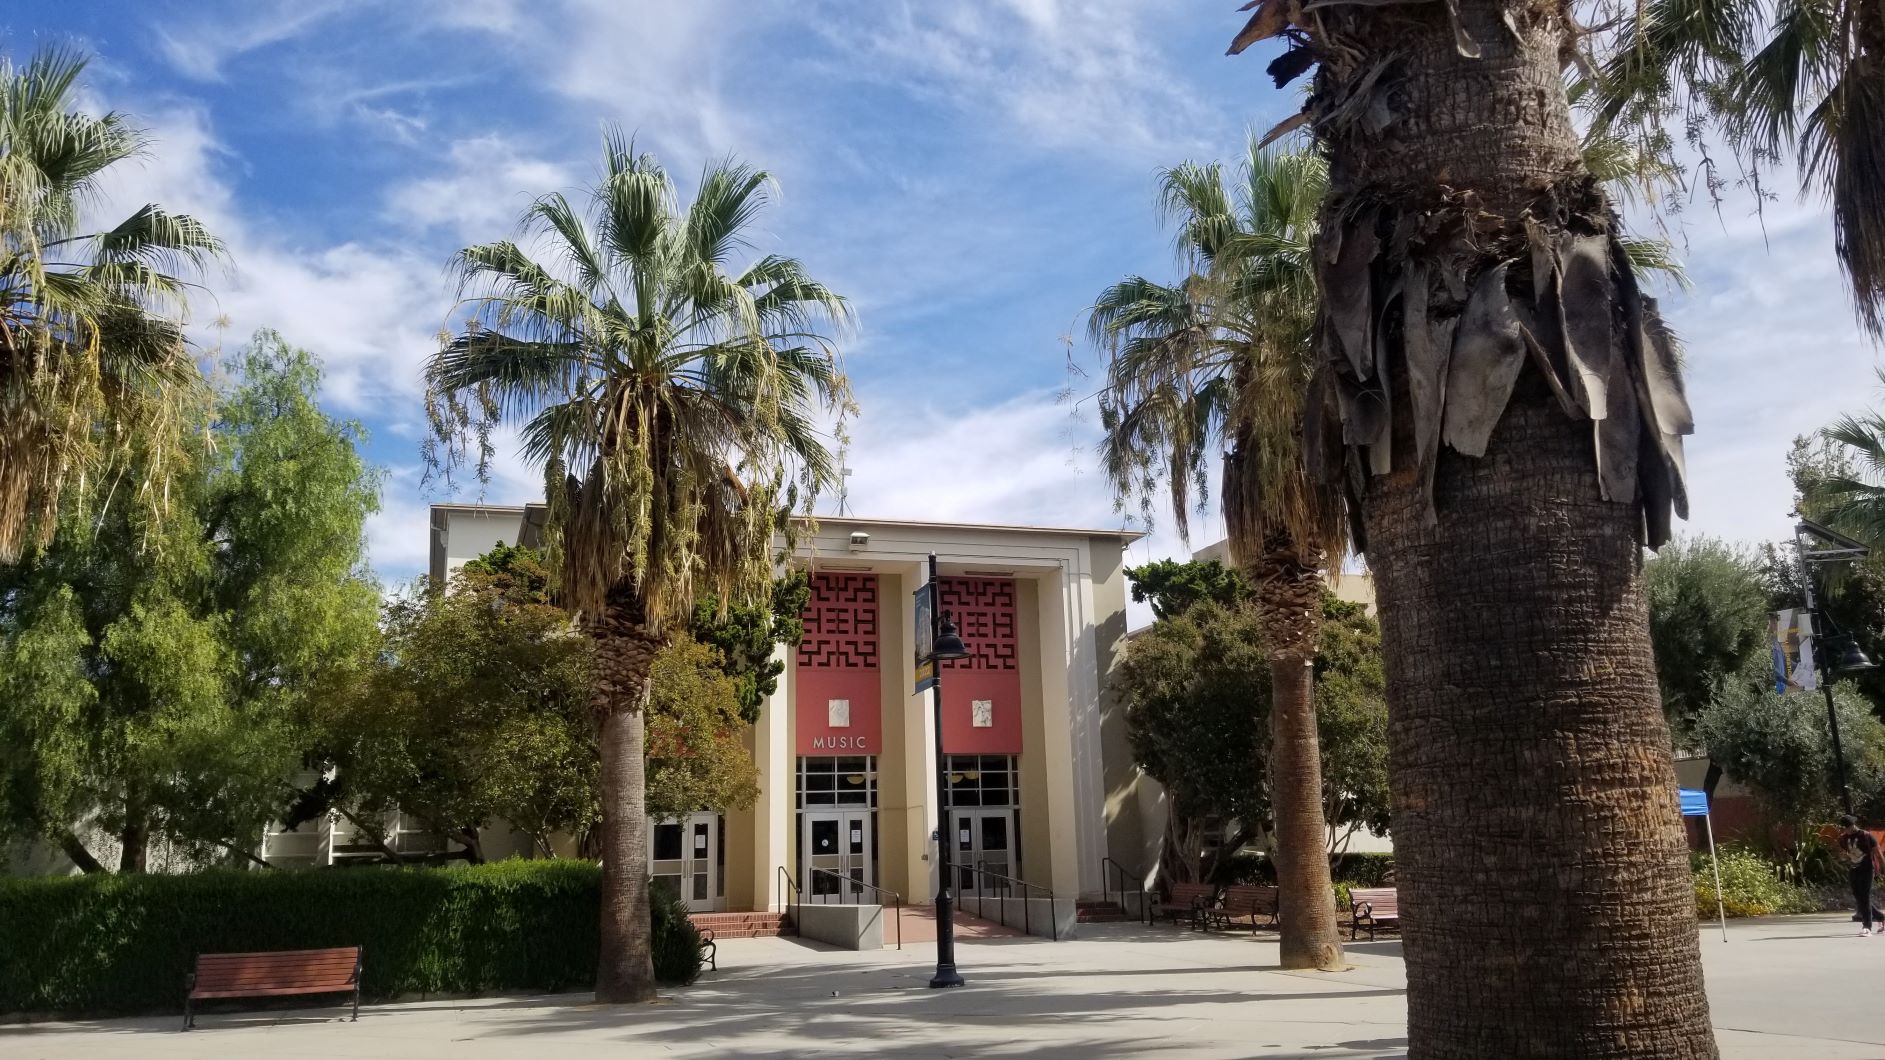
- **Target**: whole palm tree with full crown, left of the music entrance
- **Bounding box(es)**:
[426,130,848,1002]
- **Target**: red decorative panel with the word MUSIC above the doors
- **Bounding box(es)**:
[792,571,884,754]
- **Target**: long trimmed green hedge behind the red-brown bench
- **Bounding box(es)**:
[0,860,699,1013]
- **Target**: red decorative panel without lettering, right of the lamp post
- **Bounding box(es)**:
[937,577,1022,754]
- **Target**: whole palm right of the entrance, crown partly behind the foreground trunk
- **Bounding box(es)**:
[1088,140,1346,969]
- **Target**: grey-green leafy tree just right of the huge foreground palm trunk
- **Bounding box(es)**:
[1644,538,1768,743]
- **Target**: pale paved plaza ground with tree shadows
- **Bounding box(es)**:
[0,915,1885,1060]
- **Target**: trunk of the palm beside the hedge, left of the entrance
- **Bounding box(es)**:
[586,600,662,1003]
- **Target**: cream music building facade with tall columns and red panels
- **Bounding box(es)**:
[432,504,1165,911]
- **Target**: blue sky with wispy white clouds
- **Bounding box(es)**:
[0,0,1877,614]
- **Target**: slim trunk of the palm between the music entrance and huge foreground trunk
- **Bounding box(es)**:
[1252,534,1342,971]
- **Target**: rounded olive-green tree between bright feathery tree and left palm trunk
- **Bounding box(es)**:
[312,543,598,862]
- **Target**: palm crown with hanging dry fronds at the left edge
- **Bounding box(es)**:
[0,49,221,564]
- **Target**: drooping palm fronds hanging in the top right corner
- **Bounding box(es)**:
[1580,0,1885,338]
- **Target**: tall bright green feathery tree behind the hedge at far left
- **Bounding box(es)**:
[0,332,379,871]
